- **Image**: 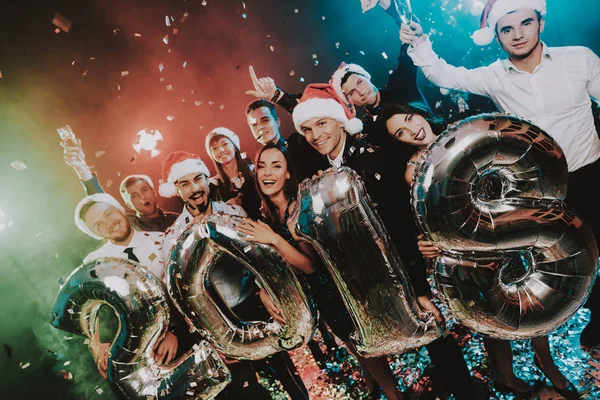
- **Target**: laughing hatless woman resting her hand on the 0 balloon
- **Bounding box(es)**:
[238,144,402,399]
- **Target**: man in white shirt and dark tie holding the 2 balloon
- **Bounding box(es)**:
[75,193,178,379]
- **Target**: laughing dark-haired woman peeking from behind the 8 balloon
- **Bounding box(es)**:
[378,103,579,399]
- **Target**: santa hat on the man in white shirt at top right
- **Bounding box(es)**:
[471,0,546,46]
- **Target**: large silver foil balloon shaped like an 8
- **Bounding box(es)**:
[412,114,598,339]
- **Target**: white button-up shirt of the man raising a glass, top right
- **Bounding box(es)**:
[408,38,600,172]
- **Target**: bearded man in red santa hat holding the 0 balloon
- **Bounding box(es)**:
[159,151,308,400]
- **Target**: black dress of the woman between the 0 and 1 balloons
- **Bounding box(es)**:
[277,200,356,341]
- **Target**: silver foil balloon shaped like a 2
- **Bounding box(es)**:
[51,257,231,400]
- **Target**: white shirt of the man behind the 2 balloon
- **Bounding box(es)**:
[83,230,165,282]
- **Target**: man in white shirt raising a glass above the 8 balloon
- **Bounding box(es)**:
[400,0,600,346]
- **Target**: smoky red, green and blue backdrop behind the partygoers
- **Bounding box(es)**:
[0,0,600,399]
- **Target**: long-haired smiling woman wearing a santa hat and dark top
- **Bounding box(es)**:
[205,128,260,219]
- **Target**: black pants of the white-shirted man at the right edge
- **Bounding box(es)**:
[567,160,600,320]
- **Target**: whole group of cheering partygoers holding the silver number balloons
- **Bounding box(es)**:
[63,0,600,399]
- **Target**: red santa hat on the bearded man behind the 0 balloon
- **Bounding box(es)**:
[158,151,210,197]
